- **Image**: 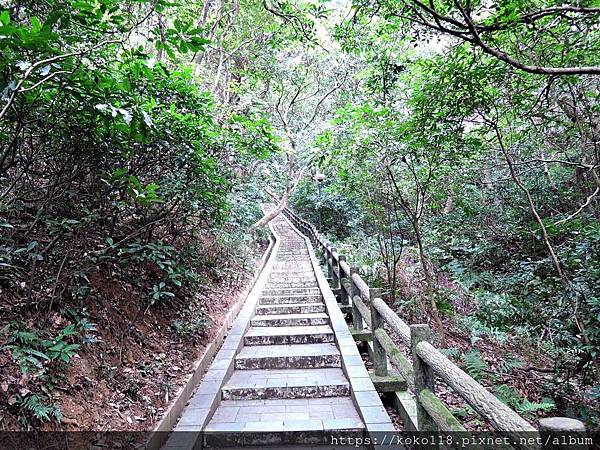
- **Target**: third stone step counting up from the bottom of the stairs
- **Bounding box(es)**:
[234,343,341,370]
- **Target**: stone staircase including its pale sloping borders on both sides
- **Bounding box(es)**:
[166,216,393,449]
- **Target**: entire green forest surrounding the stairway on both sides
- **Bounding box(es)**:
[0,0,600,427]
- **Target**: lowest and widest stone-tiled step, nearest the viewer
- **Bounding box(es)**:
[203,397,365,448]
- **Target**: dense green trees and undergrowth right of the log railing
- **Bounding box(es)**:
[294,0,600,423]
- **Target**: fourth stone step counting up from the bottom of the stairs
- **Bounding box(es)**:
[244,325,334,345]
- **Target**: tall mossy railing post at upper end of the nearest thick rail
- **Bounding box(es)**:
[410,324,437,431]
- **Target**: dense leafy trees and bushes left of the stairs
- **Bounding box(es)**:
[0,0,276,421]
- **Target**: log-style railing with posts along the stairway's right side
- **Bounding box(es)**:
[284,209,585,449]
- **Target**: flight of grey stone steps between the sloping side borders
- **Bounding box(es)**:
[204,218,364,447]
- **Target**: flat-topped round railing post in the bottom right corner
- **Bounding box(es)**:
[539,417,589,450]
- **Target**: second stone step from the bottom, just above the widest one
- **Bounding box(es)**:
[221,368,350,400]
